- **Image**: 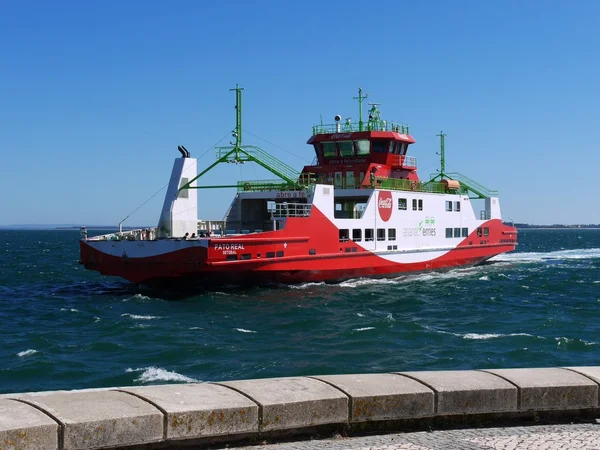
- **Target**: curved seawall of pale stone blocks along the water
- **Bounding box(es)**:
[0,366,600,450]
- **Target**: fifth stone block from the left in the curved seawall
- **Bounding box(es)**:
[313,374,434,422]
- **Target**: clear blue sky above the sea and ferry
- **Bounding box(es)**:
[0,0,600,225]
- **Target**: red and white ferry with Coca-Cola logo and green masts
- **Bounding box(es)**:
[80,85,517,286]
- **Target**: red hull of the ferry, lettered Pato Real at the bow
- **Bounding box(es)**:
[80,213,517,285]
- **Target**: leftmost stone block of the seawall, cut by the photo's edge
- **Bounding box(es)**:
[0,399,58,450]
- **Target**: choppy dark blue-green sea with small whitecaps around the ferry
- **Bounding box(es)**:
[0,229,600,393]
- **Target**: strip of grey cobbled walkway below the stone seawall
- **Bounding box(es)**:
[229,424,600,450]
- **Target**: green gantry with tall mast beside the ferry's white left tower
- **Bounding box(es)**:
[179,84,300,191]
